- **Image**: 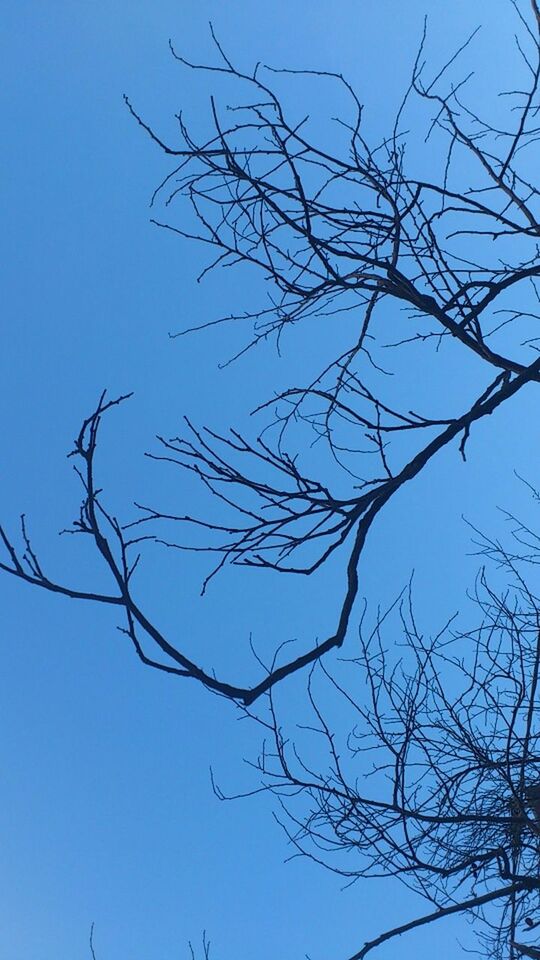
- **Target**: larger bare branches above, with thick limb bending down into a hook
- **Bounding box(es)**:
[0,7,540,705]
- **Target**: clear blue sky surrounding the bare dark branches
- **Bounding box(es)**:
[0,0,538,960]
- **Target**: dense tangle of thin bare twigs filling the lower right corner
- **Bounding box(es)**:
[228,524,540,960]
